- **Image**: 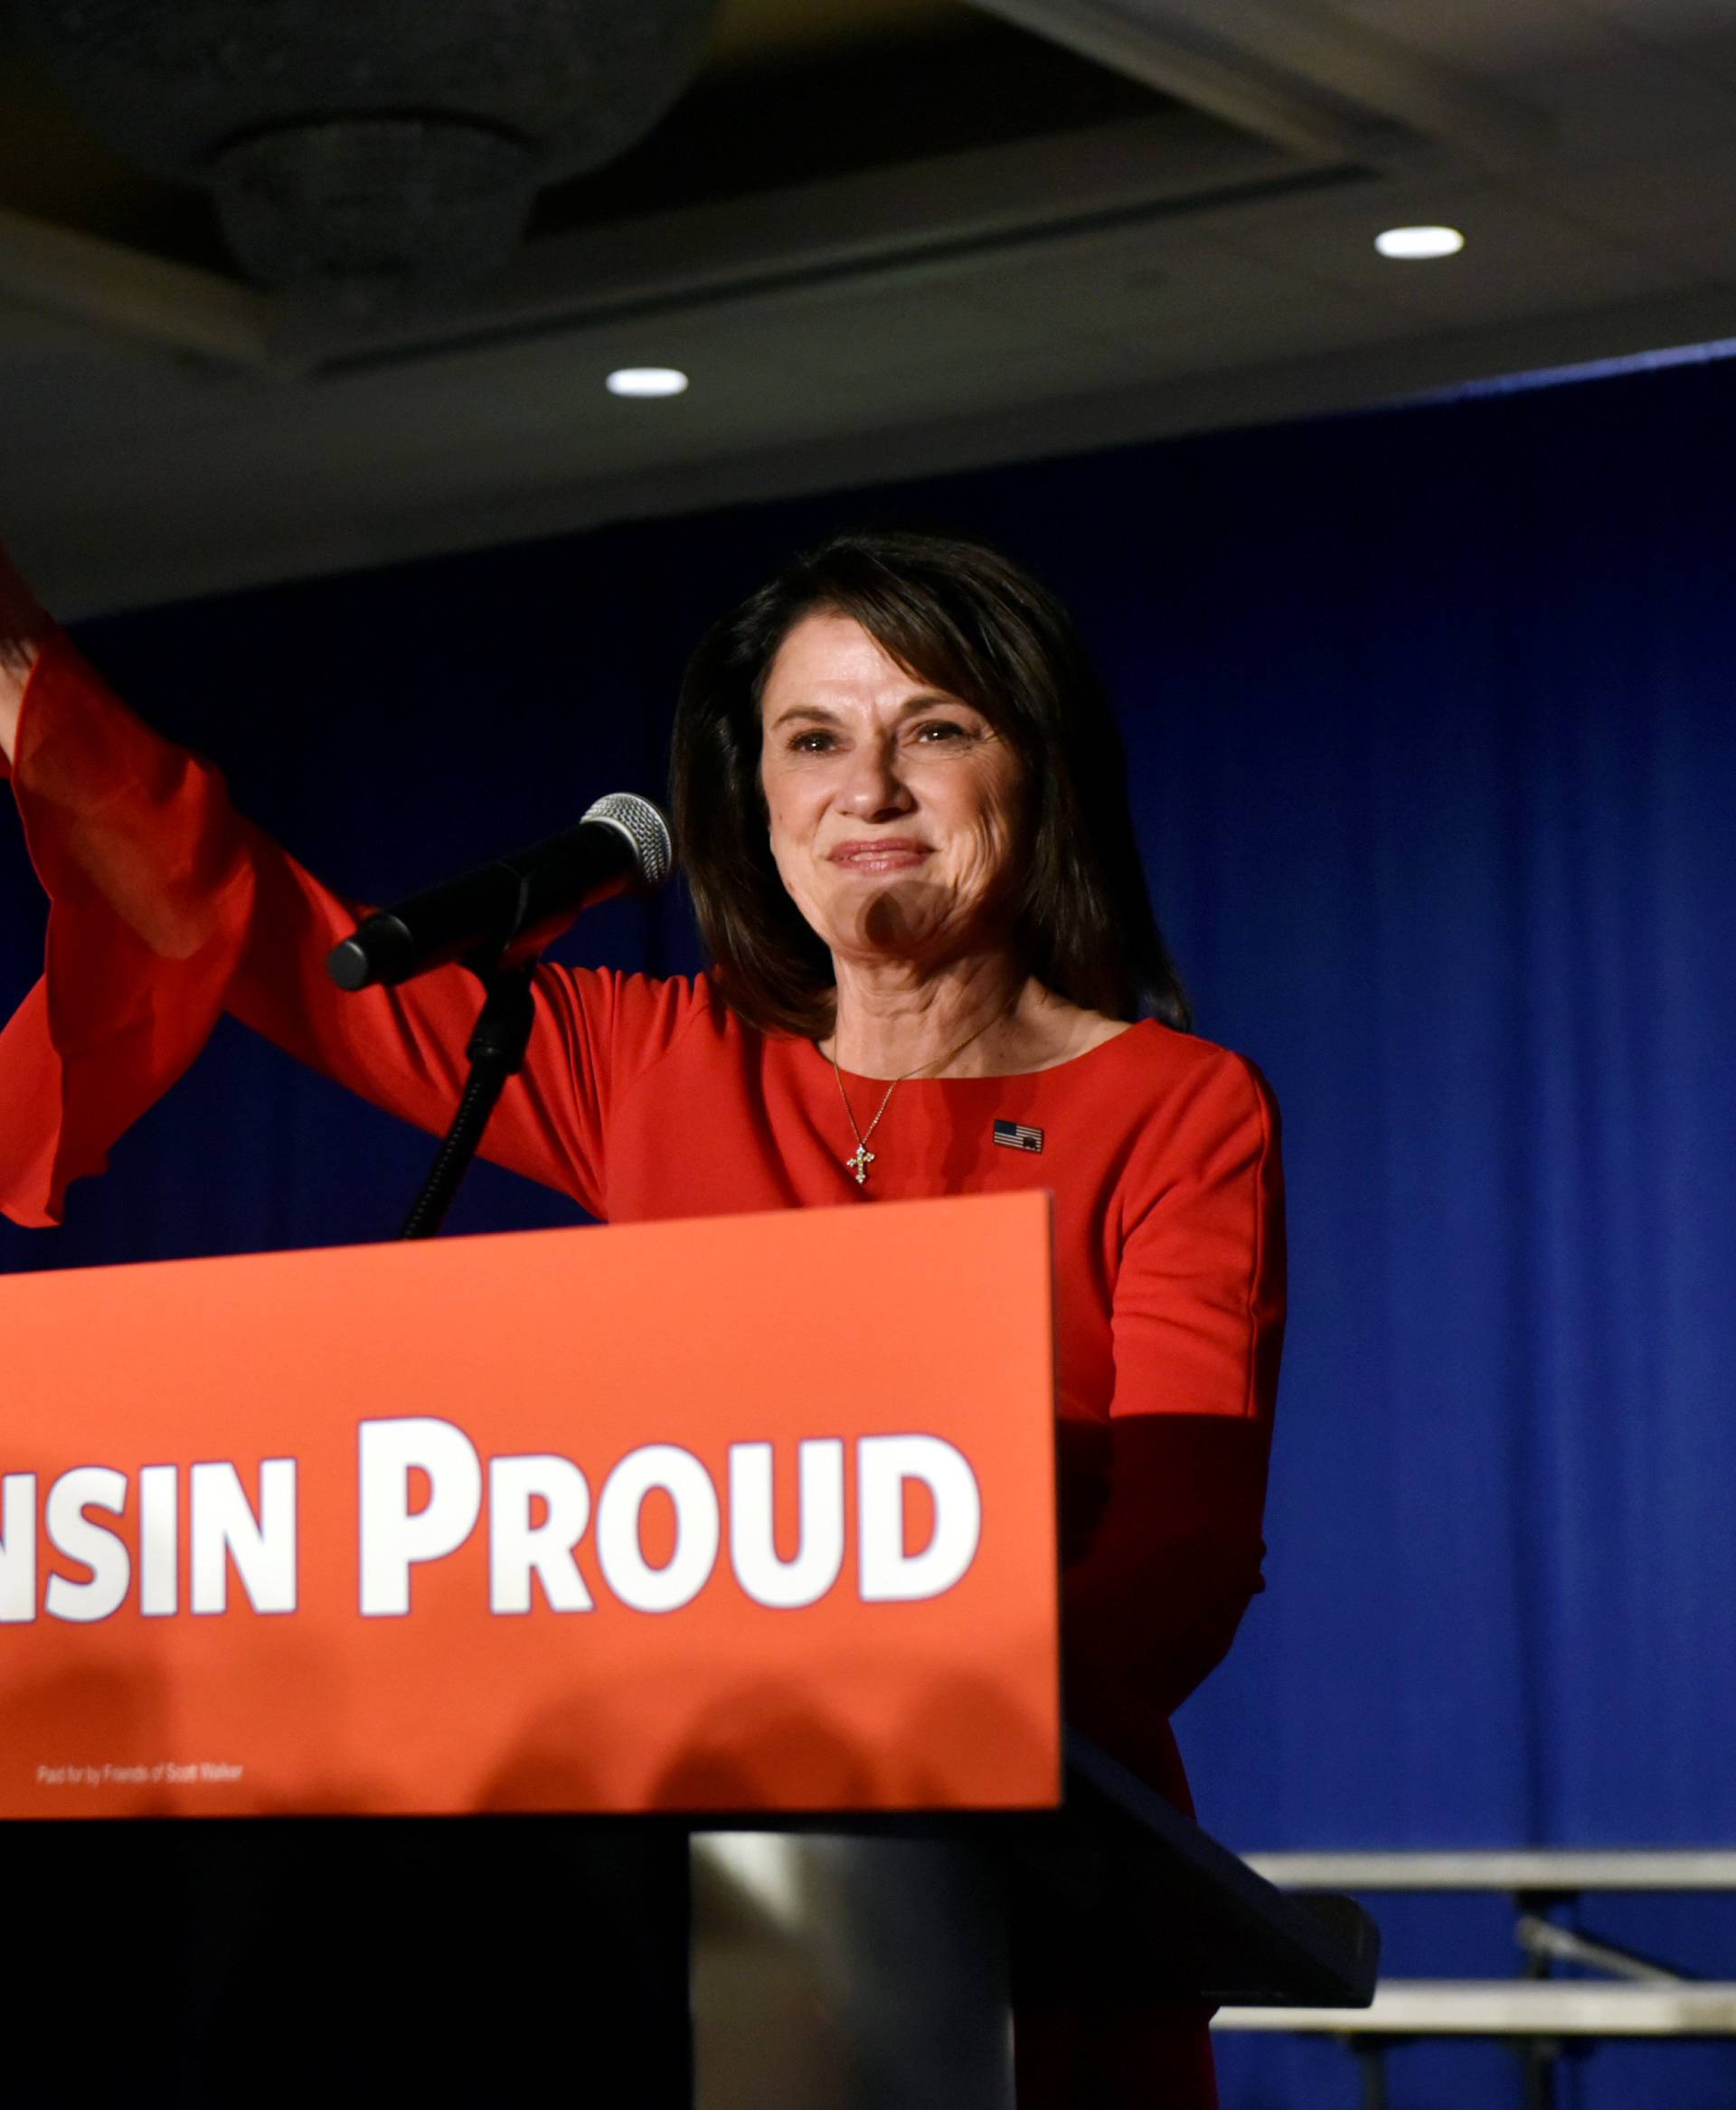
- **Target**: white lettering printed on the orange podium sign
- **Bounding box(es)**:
[0,1416,983,1620]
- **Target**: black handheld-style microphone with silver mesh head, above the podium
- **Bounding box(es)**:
[325,791,675,990]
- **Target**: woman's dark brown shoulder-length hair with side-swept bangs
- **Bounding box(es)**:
[671,534,1187,1041]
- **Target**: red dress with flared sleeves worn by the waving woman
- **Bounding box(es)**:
[0,637,1285,2104]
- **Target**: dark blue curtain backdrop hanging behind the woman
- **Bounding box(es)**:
[0,345,1736,2110]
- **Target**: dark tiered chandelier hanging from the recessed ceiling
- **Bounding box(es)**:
[13,0,717,310]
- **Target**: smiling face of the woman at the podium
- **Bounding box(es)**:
[760,612,1025,965]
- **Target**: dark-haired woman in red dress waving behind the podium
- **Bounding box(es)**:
[0,536,1282,2105]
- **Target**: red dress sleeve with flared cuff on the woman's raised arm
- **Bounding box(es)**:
[0,633,703,1224]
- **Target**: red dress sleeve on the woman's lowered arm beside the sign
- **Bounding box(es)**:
[1063,1050,1285,1766]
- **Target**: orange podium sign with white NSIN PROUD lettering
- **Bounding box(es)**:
[0,1194,1061,1817]
